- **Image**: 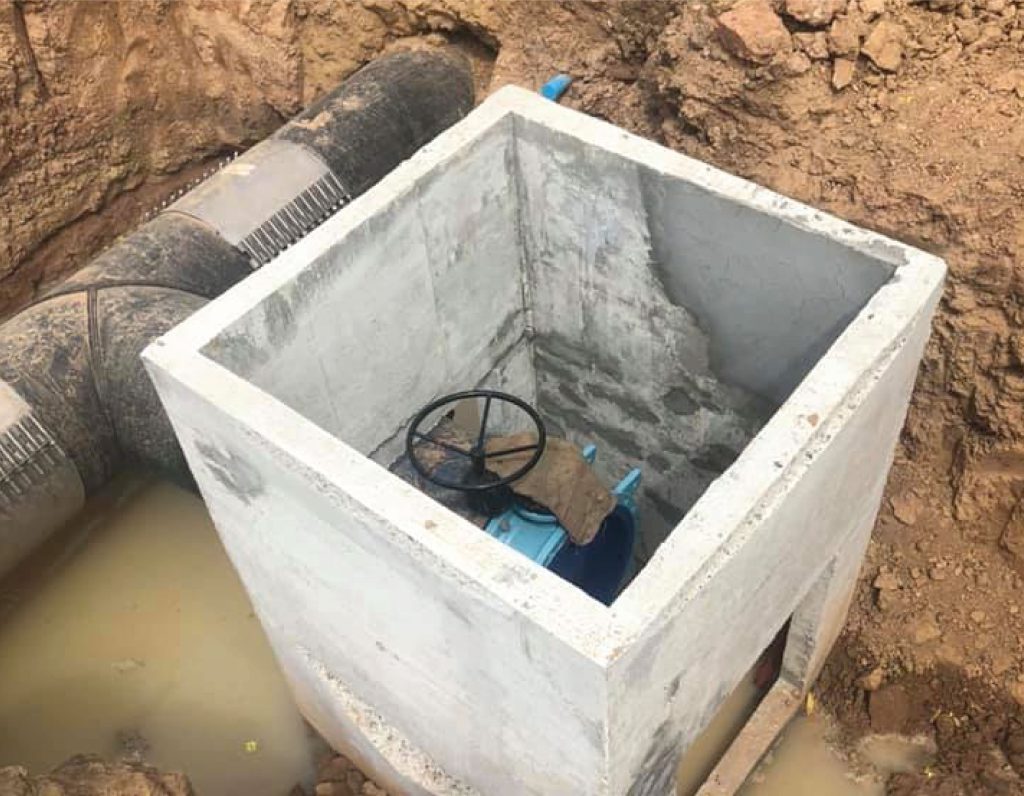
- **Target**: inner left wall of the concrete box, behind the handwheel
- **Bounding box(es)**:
[205,114,536,456]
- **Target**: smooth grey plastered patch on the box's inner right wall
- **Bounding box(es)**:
[640,168,898,406]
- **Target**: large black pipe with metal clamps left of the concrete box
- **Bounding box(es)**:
[0,51,473,576]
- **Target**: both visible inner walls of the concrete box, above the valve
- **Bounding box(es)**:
[205,105,893,585]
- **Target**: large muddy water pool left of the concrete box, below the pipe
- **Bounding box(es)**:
[0,475,312,796]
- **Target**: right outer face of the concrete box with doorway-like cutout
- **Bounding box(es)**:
[609,290,934,796]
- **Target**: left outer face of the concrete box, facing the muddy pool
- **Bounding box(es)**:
[143,353,606,796]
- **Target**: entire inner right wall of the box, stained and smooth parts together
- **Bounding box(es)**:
[515,119,893,563]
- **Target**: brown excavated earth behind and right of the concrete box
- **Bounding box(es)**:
[0,0,1024,793]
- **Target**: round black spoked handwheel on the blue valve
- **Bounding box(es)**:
[406,389,548,492]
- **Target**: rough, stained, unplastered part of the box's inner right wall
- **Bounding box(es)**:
[515,119,775,567]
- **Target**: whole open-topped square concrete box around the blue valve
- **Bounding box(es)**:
[144,88,944,796]
